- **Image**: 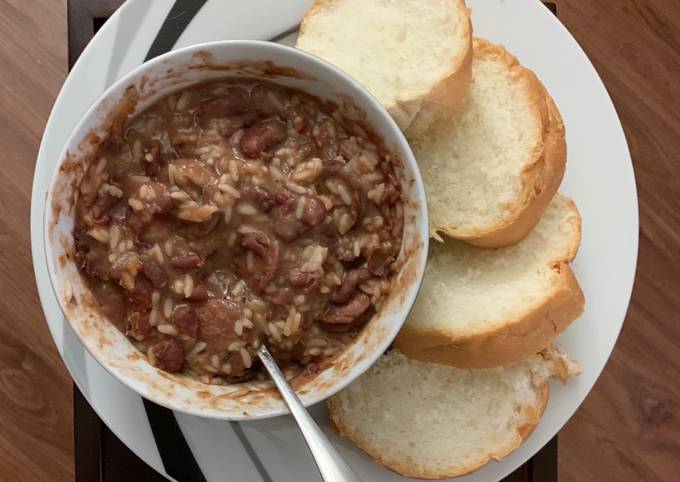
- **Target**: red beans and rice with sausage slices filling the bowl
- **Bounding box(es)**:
[74,80,403,384]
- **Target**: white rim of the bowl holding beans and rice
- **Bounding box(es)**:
[42,40,430,421]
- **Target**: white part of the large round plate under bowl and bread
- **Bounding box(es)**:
[31,0,638,482]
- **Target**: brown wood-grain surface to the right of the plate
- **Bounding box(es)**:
[559,0,680,482]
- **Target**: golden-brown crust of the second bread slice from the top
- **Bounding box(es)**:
[433,38,567,248]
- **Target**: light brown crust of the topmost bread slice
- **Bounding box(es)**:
[298,0,472,137]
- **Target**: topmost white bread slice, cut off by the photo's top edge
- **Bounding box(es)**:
[296,0,472,135]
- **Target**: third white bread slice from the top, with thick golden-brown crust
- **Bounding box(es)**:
[395,194,584,368]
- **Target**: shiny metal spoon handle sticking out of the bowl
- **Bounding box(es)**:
[257,345,362,482]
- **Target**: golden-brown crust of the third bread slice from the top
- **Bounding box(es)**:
[394,198,585,368]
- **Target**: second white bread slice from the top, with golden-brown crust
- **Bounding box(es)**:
[412,39,566,248]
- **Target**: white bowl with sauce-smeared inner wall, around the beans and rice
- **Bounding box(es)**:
[44,41,428,420]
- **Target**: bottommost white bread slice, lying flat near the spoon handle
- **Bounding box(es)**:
[328,350,580,479]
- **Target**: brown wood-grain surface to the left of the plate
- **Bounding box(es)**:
[0,0,73,482]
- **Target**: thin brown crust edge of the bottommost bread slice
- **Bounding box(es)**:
[326,370,550,480]
